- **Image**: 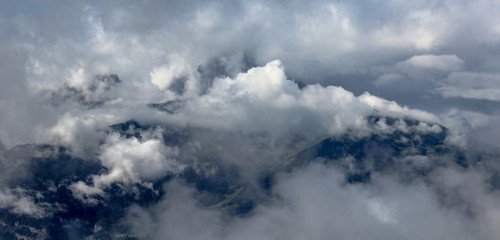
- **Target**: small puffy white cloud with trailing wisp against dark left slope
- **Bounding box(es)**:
[71,133,184,202]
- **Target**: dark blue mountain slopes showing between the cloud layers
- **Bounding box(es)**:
[0,115,500,240]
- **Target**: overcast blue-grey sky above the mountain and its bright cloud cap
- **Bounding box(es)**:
[0,1,500,146]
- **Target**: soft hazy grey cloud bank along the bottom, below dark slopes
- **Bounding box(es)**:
[126,165,492,240]
